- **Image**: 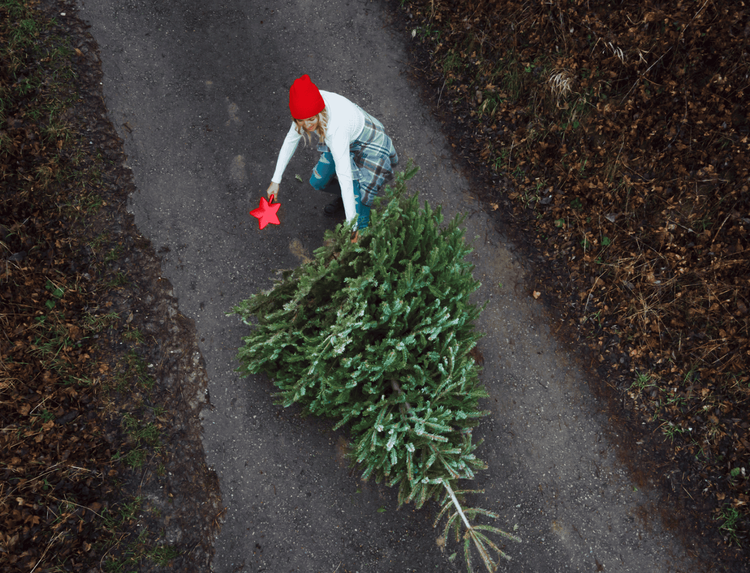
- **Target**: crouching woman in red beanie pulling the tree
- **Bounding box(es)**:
[267,74,398,229]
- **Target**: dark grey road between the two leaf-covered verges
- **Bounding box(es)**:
[73,0,706,573]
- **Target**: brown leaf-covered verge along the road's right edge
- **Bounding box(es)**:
[396,0,750,560]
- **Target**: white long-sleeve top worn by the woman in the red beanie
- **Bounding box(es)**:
[271,90,365,221]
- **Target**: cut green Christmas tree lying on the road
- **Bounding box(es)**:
[233,166,520,571]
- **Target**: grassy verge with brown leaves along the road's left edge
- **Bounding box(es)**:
[0,0,216,573]
